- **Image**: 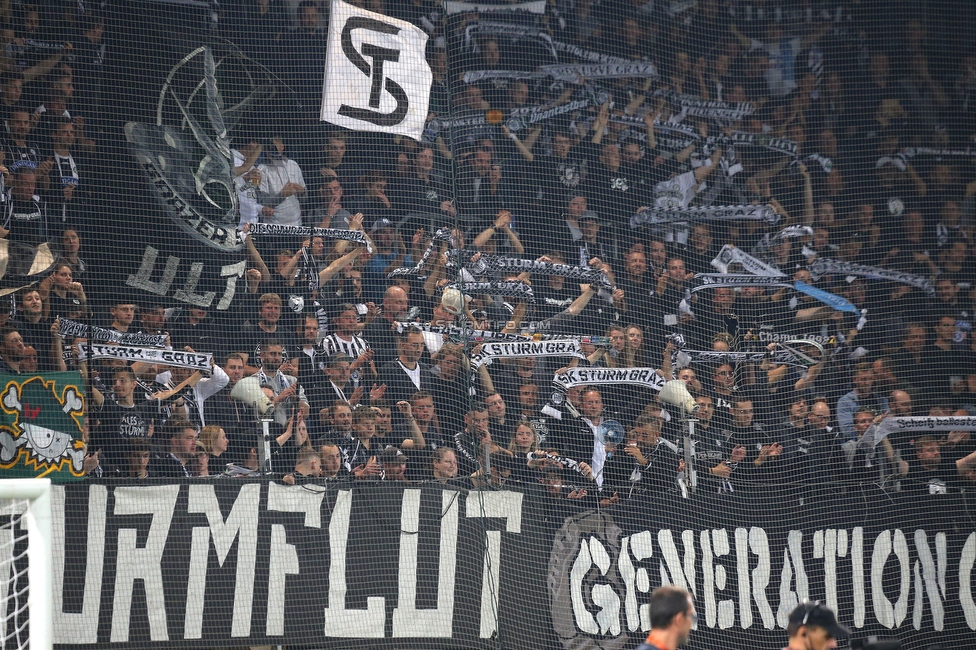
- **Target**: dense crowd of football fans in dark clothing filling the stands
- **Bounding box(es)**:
[0,0,976,506]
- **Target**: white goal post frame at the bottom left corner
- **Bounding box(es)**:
[0,478,54,650]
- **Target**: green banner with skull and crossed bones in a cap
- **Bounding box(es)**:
[0,372,85,482]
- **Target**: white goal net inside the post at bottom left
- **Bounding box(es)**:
[0,499,30,648]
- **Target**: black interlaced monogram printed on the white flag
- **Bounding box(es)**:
[338,16,410,126]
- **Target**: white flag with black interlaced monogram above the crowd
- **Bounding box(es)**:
[321,0,433,140]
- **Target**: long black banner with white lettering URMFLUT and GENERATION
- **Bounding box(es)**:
[54,479,976,649]
